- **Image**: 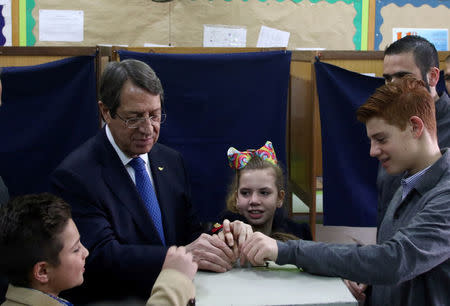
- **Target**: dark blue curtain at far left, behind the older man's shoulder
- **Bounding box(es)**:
[0,55,99,196]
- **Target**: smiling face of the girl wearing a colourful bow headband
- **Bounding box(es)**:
[236,168,284,227]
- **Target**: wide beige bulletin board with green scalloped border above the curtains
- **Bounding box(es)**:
[22,0,365,50]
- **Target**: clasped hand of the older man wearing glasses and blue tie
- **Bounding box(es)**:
[186,234,236,272]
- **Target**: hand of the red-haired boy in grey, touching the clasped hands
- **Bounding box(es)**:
[241,232,278,266]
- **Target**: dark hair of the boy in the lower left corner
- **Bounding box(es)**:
[0,193,71,287]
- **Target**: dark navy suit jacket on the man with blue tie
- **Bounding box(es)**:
[51,129,201,303]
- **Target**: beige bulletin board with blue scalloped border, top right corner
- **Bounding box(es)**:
[375,0,450,50]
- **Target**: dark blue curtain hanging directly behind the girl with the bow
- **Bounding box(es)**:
[119,51,291,221]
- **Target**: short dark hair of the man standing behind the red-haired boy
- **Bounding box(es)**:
[384,35,439,82]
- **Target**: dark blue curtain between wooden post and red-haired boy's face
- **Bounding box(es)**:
[314,62,384,226]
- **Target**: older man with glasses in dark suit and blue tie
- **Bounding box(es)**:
[52,60,247,303]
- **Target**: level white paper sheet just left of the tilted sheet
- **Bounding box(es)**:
[203,24,247,48]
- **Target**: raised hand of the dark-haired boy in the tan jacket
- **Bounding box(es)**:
[162,246,198,280]
